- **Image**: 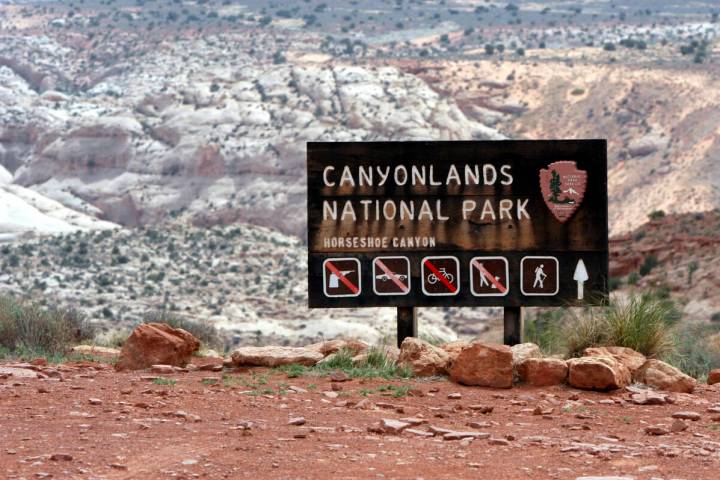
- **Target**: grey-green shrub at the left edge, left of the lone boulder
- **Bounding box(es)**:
[0,295,94,356]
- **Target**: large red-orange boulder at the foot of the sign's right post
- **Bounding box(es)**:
[448,342,513,388]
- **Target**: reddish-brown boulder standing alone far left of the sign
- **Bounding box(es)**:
[115,323,200,370]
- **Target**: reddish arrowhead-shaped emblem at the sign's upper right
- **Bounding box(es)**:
[540,160,587,223]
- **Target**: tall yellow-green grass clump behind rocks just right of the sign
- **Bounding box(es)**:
[565,293,680,358]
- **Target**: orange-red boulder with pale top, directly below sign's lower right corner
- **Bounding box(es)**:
[567,357,631,391]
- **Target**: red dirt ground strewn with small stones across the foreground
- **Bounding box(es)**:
[0,363,720,480]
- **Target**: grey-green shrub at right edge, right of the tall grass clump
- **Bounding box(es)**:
[667,324,720,380]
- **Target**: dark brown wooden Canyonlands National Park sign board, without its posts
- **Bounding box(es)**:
[307,140,608,307]
